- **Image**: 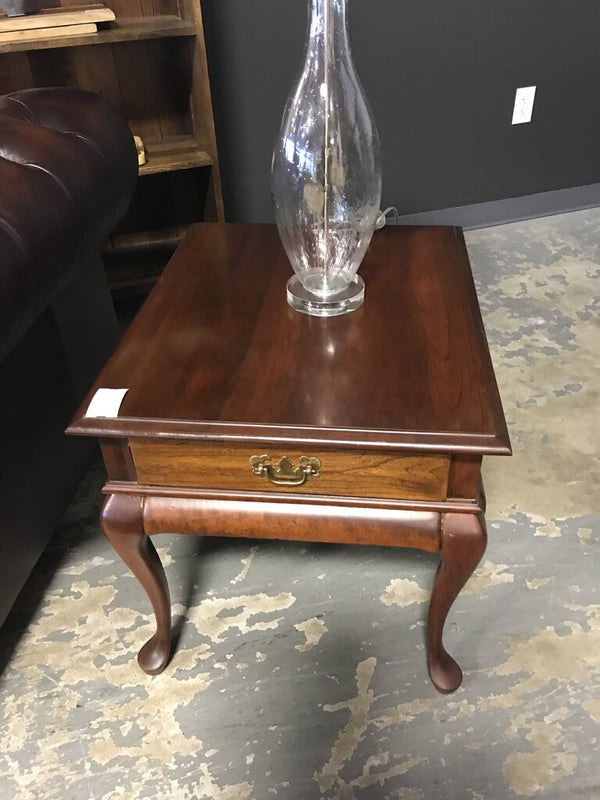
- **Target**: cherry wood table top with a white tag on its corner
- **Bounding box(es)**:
[68,223,510,455]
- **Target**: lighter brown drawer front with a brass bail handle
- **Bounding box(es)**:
[130,440,450,500]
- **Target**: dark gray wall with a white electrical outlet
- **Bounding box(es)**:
[203,0,600,221]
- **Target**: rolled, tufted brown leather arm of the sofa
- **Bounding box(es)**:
[0,88,137,360]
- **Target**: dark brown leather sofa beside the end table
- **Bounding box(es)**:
[0,88,137,624]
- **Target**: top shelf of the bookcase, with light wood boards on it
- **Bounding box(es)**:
[0,16,196,53]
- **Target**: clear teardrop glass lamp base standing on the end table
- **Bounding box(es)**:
[272,0,381,316]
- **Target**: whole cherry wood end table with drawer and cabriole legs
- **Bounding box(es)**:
[68,223,510,692]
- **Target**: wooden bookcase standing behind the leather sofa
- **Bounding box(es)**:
[0,0,224,294]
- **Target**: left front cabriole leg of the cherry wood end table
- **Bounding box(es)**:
[100,494,171,675]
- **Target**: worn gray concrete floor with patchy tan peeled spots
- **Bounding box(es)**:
[0,210,600,800]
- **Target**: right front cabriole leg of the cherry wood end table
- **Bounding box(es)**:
[427,513,487,693]
